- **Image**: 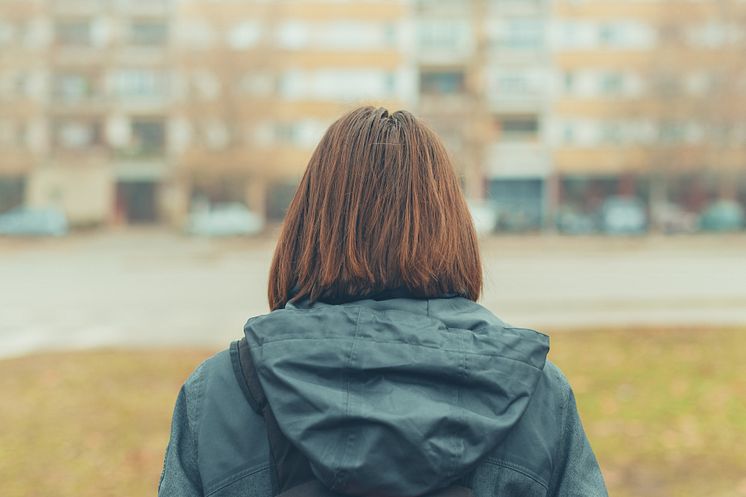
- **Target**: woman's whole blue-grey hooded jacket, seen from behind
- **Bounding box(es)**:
[158,297,607,497]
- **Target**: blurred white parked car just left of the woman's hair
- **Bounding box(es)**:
[187,203,264,236]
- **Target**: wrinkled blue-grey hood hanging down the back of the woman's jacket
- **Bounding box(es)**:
[244,297,549,497]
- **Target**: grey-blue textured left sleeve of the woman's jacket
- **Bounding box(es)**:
[158,387,202,497]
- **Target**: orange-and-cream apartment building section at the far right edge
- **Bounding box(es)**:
[547,0,746,229]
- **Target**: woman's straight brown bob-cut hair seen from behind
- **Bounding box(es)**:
[269,107,482,310]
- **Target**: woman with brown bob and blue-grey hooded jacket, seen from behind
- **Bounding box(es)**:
[159,107,606,497]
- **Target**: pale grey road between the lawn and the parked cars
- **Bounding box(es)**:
[0,230,746,356]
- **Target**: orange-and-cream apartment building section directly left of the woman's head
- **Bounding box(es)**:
[172,0,415,219]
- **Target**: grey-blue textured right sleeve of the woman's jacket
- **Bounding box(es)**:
[549,378,608,497]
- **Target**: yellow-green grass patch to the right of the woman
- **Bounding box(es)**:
[550,329,746,497]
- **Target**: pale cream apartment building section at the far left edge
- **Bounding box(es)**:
[0,0,171,225]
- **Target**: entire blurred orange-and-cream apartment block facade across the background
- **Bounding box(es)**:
[0,0,746,232]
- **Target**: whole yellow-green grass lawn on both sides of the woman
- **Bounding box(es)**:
[0,329,746,497]
